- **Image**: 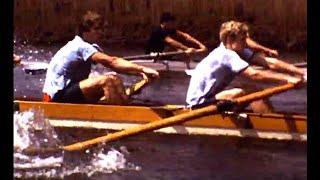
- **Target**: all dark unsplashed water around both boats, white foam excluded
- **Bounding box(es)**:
[14,44,307,180]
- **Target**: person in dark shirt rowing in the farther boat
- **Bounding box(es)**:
[145,12,207,69]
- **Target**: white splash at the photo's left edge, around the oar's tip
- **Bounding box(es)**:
[13,109,63,178]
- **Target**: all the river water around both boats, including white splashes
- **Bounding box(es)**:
[14,43,307,180]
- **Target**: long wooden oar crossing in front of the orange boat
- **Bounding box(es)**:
[24,83,296,154]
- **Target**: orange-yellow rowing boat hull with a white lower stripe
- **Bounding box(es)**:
[15,101,307,141]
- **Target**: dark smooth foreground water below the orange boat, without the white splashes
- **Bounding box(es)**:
[61,130,307,180]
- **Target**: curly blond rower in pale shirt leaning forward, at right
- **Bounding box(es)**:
[186,21,304,113]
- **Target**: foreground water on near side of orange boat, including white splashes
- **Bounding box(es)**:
[14,111,307,180]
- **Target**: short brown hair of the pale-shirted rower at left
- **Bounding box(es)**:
[78,11,103,36]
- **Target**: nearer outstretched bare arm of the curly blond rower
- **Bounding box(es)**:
[240,66,302,84]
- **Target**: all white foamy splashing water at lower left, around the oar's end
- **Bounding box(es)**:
[14,109,140,178]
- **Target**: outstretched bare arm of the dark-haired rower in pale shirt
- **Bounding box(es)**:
[91,52,159,77]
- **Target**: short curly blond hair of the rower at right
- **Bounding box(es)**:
[219,21,249,44]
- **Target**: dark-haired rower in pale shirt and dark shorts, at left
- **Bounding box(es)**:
[43,11,159,104]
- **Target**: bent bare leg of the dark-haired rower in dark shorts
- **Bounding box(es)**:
[79,75,128,104]
